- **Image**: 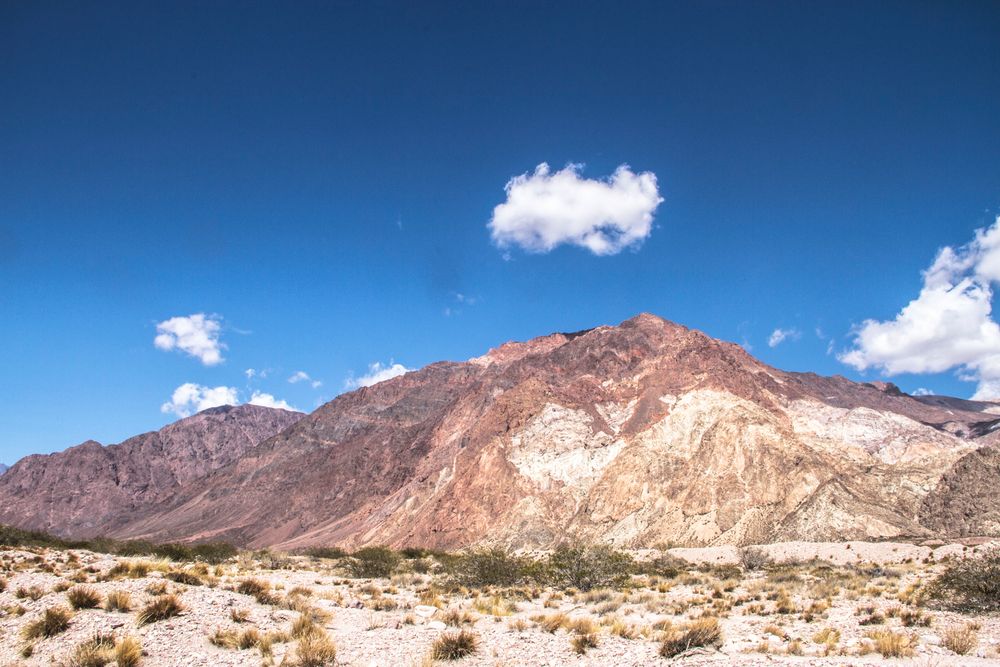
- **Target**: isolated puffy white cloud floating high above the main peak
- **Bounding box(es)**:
[488,162,663,255]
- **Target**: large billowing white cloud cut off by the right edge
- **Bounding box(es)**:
[838,217,1000,399]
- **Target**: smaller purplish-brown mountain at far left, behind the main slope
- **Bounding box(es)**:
[0,405,304,537]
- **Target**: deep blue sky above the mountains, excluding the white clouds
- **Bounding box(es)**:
[0,2,1000,463]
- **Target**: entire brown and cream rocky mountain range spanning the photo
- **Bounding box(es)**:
[0,314,1000,548]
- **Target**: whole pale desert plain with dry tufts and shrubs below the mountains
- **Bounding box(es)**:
[0,542,1000,667]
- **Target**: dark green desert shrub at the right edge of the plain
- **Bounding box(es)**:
[927,548,1000,614]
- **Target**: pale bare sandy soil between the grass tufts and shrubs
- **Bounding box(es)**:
[0,542,1000,667]
